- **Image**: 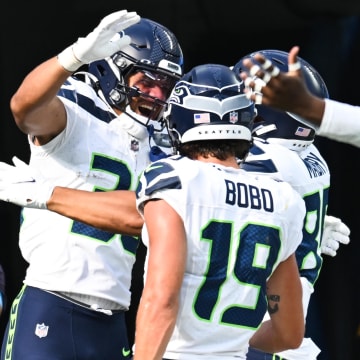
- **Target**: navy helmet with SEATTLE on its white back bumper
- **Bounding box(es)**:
[164,64,255,148]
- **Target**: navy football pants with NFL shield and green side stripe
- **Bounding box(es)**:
[1,286,132,360]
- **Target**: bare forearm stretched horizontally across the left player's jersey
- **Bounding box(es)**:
[47,186,143,236]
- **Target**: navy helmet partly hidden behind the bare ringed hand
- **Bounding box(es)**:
[233,50,329,151]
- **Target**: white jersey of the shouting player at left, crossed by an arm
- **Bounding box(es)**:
[20,78,149,308]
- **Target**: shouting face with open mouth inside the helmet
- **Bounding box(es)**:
[128,70,175,120]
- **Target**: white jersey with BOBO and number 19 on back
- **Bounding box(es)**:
[137,156,305,360]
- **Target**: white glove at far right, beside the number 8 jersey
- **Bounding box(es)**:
[321,215,350,257]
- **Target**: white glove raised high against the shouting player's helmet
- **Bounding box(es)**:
[58,10,140,72]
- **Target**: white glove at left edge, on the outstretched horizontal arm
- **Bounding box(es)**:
[0,156,54,209]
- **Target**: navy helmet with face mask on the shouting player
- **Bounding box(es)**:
[88,18,183,120]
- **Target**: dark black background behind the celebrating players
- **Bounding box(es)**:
[0,0,360,360]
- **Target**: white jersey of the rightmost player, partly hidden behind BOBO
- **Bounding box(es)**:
[241,138,330,360]
